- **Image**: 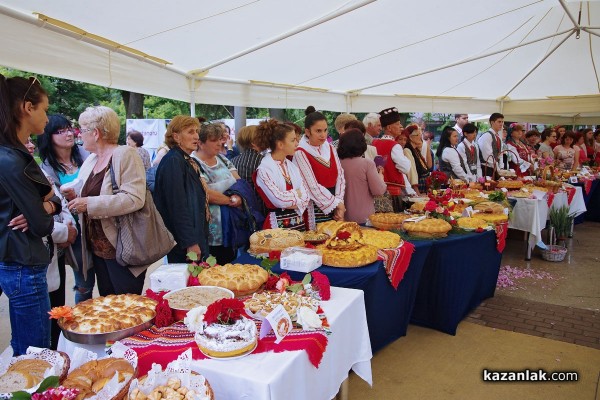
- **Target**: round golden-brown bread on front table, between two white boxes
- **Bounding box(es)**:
[198,264,269,296]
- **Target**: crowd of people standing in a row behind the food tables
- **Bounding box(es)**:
[0,75,600,355]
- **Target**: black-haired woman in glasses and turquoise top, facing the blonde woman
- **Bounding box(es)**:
[38,114,96,304]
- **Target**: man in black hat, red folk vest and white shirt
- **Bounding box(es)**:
[373,107,415,212]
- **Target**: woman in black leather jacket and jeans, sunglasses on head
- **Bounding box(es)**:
[0,74,61,355]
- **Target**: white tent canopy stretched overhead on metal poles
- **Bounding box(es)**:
[0,0,600,123]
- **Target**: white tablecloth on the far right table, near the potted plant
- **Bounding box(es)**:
[508,186,586,249]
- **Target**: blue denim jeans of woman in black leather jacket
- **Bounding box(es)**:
[0,262,50,355]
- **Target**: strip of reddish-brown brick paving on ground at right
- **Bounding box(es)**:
[465,295,600,350]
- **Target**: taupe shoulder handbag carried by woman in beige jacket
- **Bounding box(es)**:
[110,163,175,266]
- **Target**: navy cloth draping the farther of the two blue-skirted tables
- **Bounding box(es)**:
[410,231,502,335]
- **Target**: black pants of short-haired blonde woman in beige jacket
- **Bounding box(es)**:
[93,255,146,296]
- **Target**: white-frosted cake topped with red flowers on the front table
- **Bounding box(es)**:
[192,299,257,358]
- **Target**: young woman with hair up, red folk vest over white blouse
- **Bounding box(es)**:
[293,107,346,230]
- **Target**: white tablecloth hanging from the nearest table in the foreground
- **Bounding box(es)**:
[58,287,373,400]
